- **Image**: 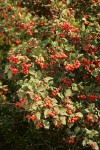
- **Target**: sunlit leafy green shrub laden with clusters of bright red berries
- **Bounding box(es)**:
[0,0,100,150]
